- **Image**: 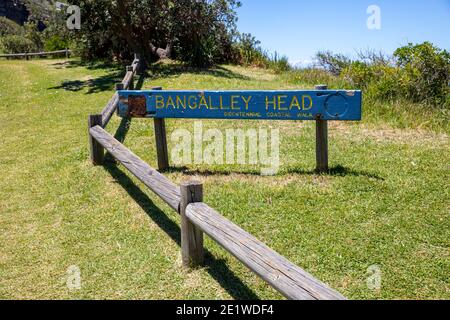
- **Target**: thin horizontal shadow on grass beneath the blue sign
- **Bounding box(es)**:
[165,165,384,181]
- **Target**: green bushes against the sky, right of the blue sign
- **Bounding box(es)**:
[308,42,450,108]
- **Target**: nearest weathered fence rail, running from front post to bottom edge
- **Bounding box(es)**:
[186,203,345,300]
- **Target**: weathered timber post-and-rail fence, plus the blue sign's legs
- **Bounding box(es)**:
[88,53,345,300]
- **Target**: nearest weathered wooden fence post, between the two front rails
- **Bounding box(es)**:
[180,181,204,268]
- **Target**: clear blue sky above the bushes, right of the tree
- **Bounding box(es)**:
[238,0,450,64]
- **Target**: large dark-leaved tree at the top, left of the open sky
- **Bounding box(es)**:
[73,0,240,66]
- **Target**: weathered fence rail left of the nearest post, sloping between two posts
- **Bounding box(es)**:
[90,126,181,212]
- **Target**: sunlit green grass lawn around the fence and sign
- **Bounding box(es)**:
[0,60,450,299]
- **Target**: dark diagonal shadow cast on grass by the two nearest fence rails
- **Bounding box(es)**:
[105,164,258,300]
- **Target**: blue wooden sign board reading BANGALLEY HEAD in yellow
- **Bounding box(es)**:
[118,90,362,120]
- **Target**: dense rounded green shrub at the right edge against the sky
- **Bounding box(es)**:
[394,42,450,105]
